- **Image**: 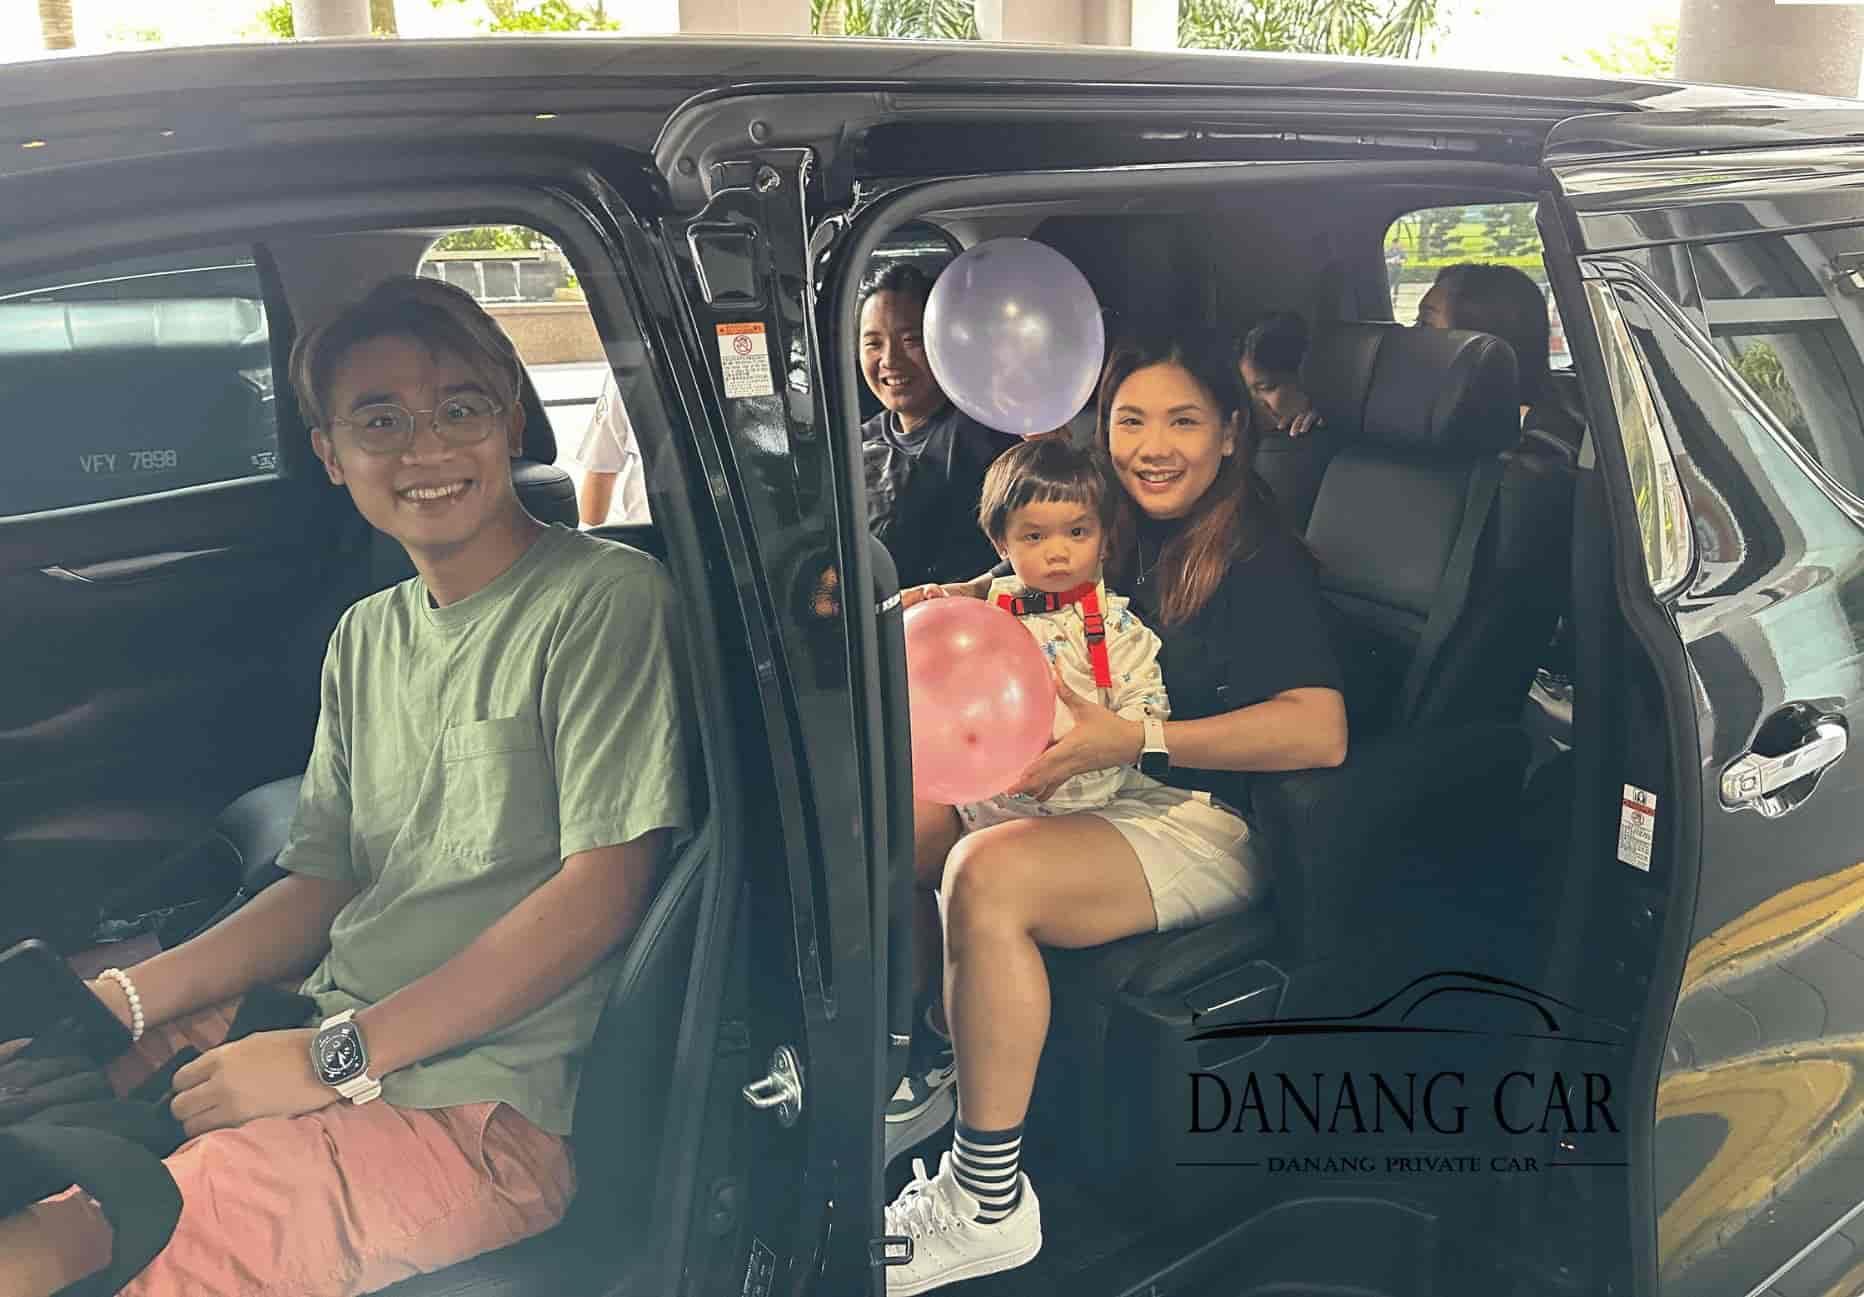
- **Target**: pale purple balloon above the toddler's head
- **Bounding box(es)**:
[925,239,1107,436]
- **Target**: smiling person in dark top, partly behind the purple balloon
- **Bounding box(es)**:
[859,265,1016,589]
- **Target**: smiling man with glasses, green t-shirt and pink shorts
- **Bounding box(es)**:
[0,278,690,1297]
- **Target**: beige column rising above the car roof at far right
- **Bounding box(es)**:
[1676,0,1864,99]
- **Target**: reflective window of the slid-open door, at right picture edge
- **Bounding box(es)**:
[1689,227,1864,496]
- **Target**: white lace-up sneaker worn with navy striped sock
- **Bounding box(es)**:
[885,1154,1042,1297]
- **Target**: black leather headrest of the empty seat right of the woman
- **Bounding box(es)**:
[1303,322,1521,458]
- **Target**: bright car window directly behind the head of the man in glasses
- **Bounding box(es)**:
[419,225,652,526]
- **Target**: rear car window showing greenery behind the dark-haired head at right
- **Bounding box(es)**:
[1385,203,1573,369]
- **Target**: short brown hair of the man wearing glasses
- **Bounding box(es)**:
[291,274,524,429]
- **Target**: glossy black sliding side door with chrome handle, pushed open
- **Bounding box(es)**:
[1545,110,1864,1297]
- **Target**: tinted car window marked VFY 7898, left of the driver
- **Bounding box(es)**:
[0,248,278,516]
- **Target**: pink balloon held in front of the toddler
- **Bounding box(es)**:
[906,598,1055,805]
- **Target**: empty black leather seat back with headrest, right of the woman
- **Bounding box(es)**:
[1305,324,1571,734]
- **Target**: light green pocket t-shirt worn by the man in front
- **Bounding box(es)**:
[278,527,690,1135]
